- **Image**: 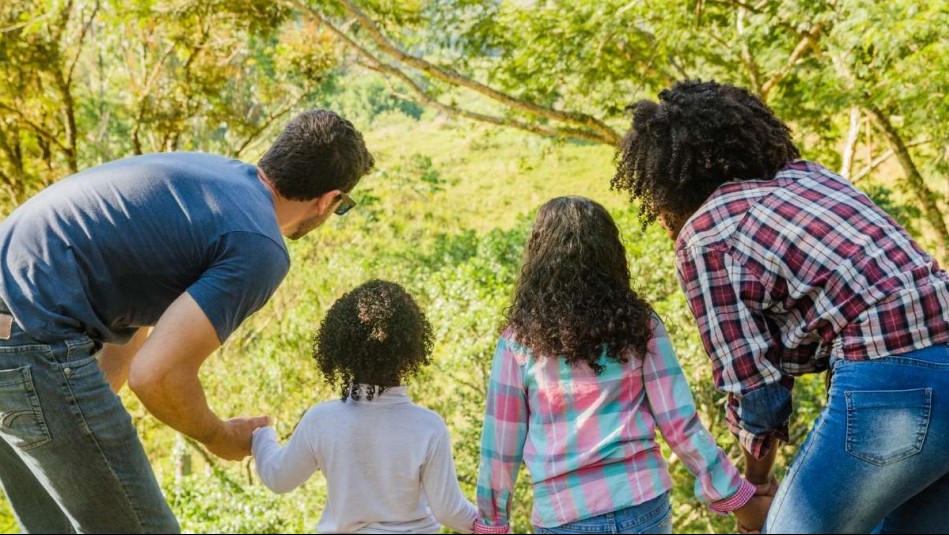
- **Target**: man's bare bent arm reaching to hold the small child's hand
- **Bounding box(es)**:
[128,293,270,460]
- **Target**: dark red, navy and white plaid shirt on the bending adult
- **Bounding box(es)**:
[676,160,949,458]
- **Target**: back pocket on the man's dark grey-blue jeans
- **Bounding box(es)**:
[0,366,52,451]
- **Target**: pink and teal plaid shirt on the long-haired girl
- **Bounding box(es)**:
[476,318,755,532]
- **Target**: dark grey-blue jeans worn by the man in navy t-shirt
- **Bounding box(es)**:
[0,316,179,533]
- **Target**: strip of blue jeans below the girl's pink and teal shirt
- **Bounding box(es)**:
[534,492,672,533]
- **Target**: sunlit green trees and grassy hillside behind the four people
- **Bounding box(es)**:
[0,0,949,533]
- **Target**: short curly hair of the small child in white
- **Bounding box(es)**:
[313,280,432,401]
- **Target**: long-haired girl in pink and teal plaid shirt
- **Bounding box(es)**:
[475,197,768,533]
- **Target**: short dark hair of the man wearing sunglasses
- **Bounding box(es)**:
[258,110,375,201]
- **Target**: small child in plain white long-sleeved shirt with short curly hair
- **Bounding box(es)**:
[253,280,477,533]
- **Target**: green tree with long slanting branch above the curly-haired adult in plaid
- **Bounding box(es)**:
[296,0,949,258]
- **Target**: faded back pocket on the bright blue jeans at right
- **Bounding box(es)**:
[844,388,932,466]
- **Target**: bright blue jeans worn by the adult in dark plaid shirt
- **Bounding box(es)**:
[765,345,949,533]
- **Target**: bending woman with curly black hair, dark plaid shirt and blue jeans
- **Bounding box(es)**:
[612,81,949,533]
